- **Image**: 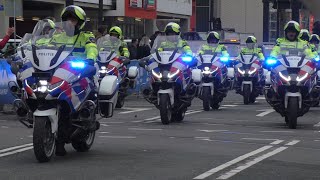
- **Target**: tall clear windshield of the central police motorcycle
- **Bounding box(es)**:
[151,35,184,64]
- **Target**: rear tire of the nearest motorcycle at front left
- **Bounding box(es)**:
[72,131,96,152]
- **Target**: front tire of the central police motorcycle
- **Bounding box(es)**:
[159,94,172,125]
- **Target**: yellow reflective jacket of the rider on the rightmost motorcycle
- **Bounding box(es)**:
[270,38,316,59]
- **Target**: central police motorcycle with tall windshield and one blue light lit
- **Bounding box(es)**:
[139,35,196,124]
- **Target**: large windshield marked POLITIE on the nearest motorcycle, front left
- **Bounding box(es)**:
[20,21,75,71]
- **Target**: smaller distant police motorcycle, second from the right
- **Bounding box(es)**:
[234,53,265,104]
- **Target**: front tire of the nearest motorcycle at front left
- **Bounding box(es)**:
[33,117,56,163]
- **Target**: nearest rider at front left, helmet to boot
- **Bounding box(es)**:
[50,5,98,156]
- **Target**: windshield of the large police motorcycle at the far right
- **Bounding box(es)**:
[279,47,309,68]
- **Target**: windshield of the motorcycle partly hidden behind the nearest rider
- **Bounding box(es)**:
[97,35,122,63]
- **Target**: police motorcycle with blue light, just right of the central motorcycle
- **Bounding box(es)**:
[192,42,231,111]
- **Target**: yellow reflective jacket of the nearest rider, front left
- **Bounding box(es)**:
[50,32,98,61]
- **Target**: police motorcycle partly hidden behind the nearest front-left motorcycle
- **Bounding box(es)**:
[98,35,138,108]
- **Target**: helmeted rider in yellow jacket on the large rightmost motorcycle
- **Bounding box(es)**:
[270,21,315,59]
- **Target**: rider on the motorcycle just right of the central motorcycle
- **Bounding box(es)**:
[199,31,229,56]
